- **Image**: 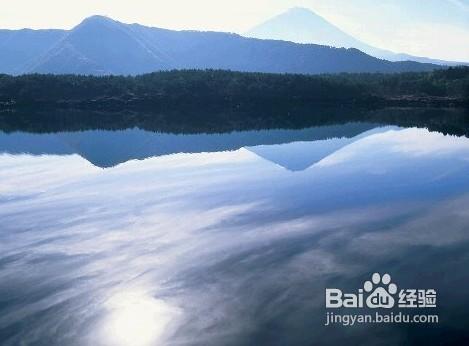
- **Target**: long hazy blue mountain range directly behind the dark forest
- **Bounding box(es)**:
[0,16,439,75]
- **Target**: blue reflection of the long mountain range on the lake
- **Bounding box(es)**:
[0,123,377,168]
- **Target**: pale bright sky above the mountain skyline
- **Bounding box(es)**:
[0,0,469,61]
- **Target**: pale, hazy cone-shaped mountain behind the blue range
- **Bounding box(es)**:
[245,7,464,65]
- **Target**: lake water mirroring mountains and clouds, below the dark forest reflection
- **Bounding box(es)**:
[0,107,469,346]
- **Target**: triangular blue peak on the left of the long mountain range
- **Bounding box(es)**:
[31,16,170,74]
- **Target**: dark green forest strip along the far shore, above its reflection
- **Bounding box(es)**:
[0,67,469,110]
